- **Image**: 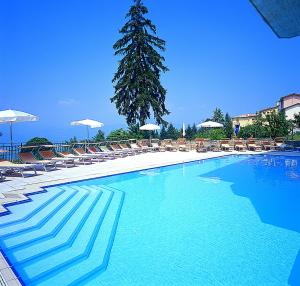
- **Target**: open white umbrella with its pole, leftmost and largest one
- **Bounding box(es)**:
[0,109,39,159]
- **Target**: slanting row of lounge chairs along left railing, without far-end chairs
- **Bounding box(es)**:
[0,141,162,181]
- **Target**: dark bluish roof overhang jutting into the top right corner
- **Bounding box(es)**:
[250,0,300,38]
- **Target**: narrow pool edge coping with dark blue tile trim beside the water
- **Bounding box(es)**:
[0,151,300,286]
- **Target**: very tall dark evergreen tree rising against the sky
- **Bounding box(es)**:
[111,0,169,125]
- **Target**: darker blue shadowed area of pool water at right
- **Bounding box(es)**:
[202,156,300,286]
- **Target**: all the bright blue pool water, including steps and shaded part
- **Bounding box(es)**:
[0,155,300,286]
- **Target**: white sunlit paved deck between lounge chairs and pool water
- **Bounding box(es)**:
[0,151,300,286]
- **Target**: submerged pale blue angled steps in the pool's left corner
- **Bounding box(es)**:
[0,185,124,285]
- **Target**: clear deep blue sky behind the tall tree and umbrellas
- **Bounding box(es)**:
[0,0,300,142]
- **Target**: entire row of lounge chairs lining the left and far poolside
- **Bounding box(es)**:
[0,138,292,180]
